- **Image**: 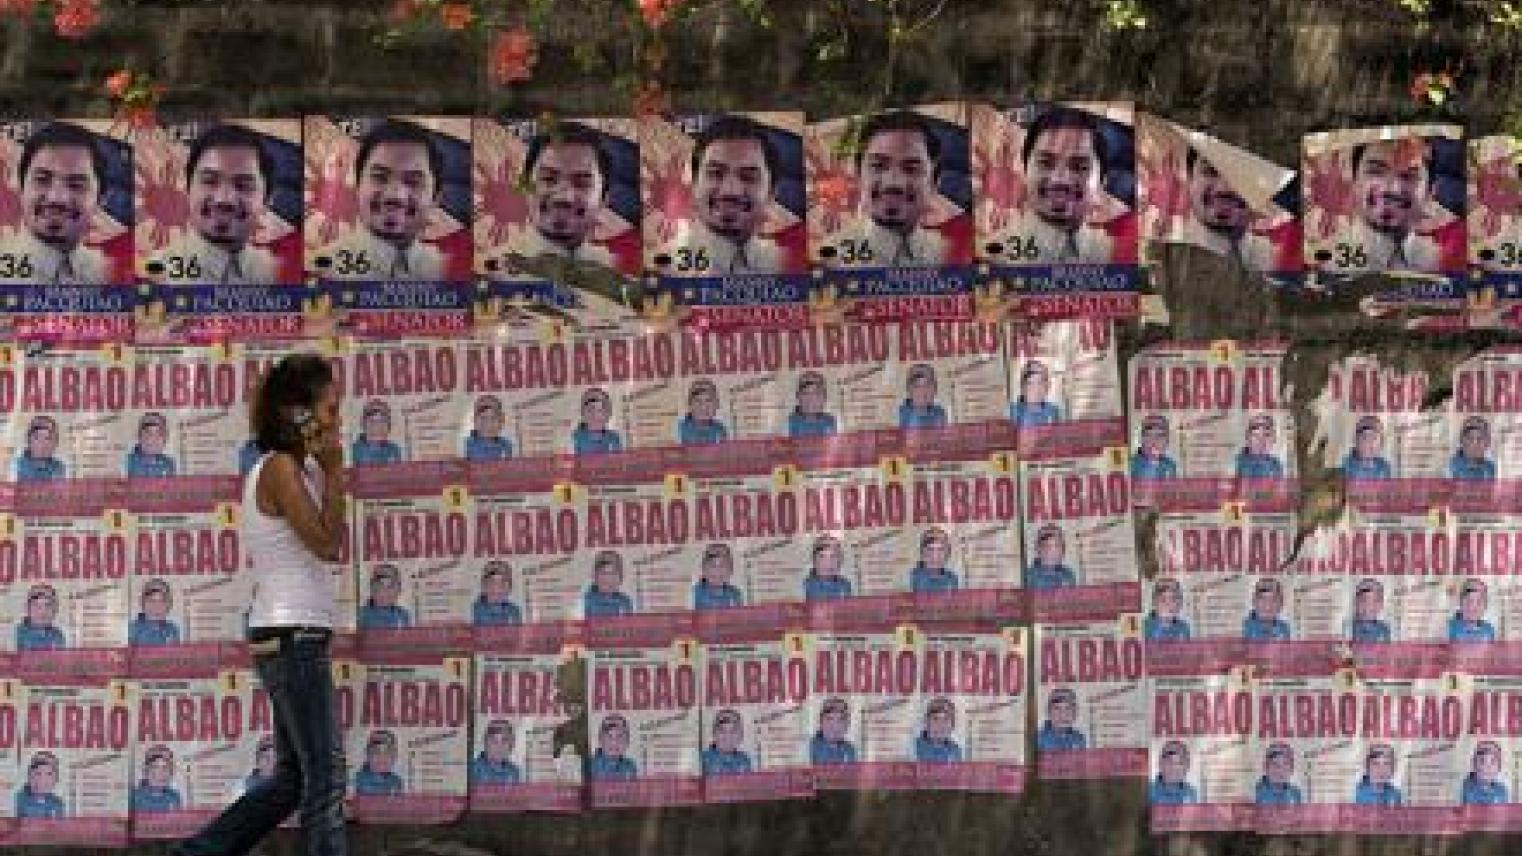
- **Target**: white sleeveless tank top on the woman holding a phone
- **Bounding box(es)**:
[240,452,338,628]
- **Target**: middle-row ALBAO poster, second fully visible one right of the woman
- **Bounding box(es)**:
[454,481,592,650]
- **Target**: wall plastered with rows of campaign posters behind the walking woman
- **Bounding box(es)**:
[0,1,1517,853]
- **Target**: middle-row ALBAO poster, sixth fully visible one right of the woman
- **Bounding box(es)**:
[901,454,1026,621]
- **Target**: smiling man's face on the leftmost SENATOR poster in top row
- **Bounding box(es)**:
[21,146,100,250]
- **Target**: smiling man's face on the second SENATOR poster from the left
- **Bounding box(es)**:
[186,146,268,250]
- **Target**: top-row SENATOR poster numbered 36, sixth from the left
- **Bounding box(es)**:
[804,102,974,321]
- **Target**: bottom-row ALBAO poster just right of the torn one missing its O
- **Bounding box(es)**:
[587,638,703,809]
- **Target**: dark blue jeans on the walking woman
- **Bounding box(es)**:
[174,629,349,856]
